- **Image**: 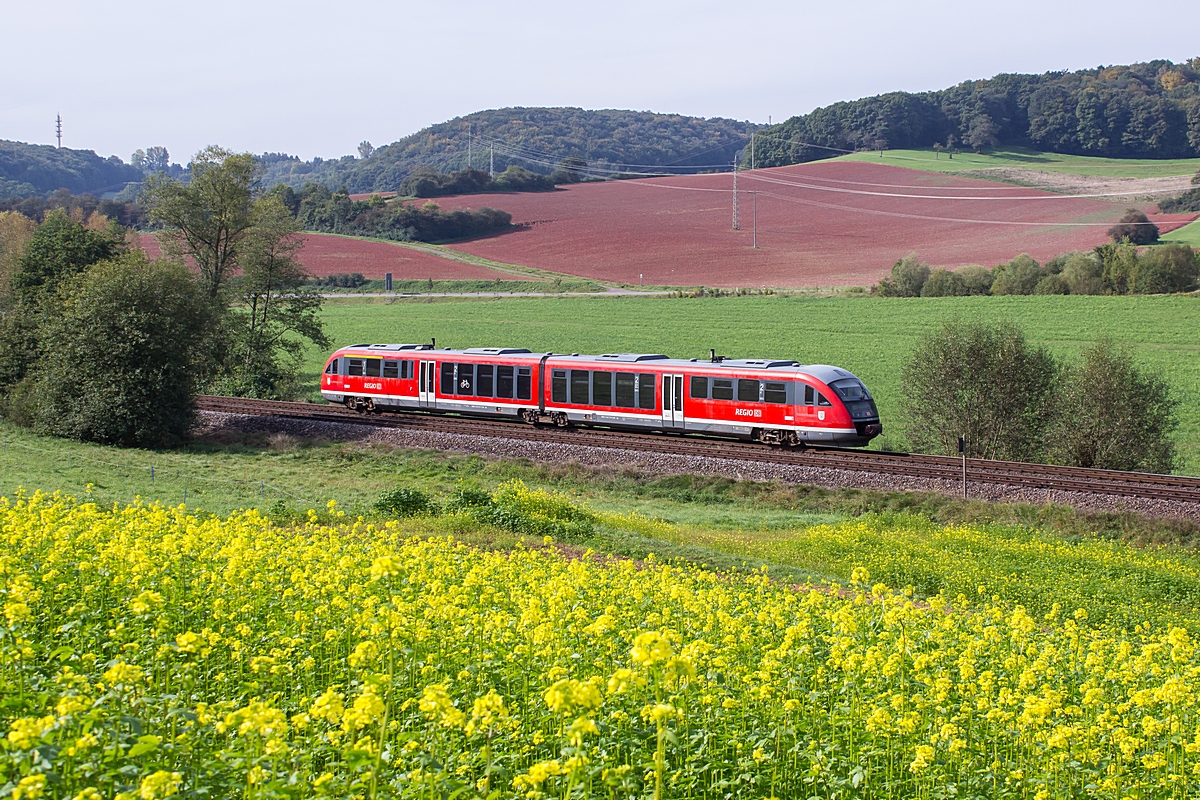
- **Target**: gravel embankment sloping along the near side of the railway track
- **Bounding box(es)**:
[199,411,1200,519]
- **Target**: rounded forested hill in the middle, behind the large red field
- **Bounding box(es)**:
[263,108,756,192]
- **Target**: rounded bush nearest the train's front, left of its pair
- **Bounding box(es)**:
[900,320,1057,461]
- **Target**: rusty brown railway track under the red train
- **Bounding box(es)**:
[197,396,1200,504]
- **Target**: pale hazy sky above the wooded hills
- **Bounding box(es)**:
[0,0,1200,163]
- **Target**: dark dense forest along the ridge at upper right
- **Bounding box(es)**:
[744,58,1200,167]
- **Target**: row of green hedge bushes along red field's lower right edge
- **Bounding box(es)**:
[876,243,1200,297]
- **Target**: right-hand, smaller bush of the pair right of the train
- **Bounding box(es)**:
[1048,338,1178,473]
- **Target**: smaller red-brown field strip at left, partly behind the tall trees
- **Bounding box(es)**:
[140,234,522,281]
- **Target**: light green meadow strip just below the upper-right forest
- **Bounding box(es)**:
[834,148,1200,178]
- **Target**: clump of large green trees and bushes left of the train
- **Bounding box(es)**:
[0,148,329,446]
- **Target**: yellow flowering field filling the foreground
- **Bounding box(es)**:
[0,494,1200,800]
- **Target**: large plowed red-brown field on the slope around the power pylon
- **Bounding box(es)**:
[436,162,1176,287]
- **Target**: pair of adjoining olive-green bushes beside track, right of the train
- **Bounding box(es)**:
[900,319,1180,473]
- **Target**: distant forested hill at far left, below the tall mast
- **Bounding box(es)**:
[0,139,142,199]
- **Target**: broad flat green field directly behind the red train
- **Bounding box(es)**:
[306,295,1200,475]
